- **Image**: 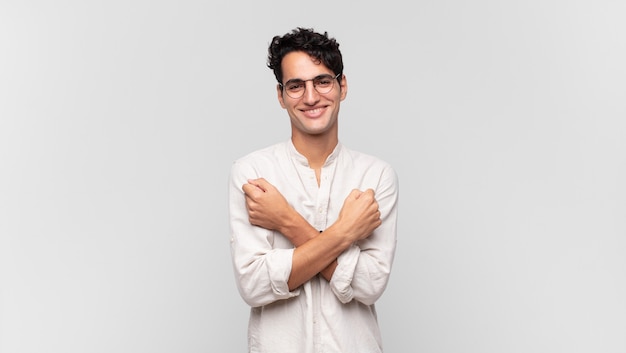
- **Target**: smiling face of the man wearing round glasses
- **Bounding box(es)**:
[277,51,348,135]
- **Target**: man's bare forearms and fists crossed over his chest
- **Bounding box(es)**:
[242,178,381,290]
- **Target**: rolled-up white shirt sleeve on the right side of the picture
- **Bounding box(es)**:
[330,167,398,305]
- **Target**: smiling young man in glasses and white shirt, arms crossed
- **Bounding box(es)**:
[229,28,398,353]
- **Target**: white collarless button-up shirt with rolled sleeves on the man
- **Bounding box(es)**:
[229,140,398,353]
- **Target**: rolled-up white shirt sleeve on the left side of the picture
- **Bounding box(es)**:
[228,162,299,307]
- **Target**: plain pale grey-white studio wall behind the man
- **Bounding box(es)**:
[0,0,626,353]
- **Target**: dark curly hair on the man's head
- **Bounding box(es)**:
[267,27,343,84]
